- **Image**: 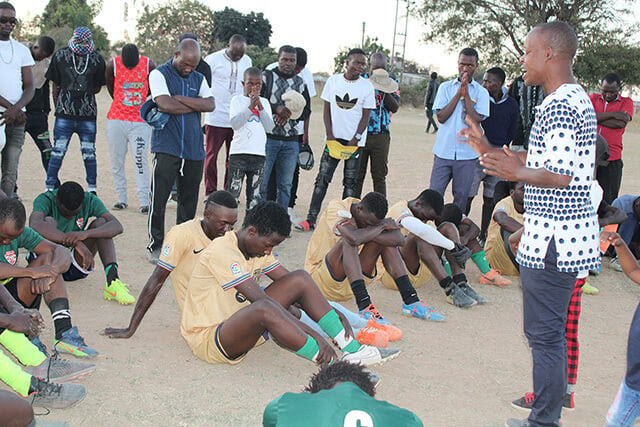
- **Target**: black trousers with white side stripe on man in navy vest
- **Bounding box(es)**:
[147,153,204,251]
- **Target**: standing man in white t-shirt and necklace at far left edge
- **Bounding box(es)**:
[0,2,35,200]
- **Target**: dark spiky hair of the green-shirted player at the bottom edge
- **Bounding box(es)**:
[304,361,376,397]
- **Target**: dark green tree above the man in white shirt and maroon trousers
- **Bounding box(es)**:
[212,7,272,47]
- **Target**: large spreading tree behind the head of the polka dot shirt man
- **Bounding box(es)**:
[415,0,640,84]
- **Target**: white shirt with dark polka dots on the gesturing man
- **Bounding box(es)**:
[517,84,600,272]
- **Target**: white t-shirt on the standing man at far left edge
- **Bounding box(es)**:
[0,38,35,111]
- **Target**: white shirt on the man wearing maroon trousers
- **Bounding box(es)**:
[204,49,252,128]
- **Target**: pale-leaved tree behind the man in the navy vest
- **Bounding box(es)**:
[136,0,214,64]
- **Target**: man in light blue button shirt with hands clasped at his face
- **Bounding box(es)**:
[429,48,489,212]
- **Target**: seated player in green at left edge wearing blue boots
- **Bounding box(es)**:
[0,199,98,357]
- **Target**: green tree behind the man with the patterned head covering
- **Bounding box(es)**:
[38,0,109,56]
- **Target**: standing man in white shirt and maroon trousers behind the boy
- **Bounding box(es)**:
[204,34,252,195]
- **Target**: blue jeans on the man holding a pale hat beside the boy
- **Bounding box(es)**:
[260,138,300,209]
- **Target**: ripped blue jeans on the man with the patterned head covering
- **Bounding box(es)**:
[45,117,98,191]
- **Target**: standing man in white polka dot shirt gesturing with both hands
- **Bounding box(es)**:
[461,21,600,426]
